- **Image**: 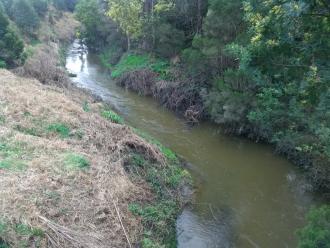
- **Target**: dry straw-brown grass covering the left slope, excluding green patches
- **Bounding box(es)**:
[0,70,164,247]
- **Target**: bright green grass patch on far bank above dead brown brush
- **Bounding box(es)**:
[111,54,171,80]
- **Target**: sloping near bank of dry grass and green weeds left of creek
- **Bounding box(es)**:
[0,67,189,247]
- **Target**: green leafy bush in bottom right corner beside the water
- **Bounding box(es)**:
[298,206,330,248]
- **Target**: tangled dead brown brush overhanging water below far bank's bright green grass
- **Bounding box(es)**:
[117,69,206,123]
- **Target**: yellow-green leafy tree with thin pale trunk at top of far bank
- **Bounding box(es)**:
[107,0,143,50]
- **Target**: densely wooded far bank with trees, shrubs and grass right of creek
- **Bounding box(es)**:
[75,0,330,193]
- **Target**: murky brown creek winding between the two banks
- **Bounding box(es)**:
[66,41,316,248]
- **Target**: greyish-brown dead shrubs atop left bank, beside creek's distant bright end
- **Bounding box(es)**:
[15,12,79,87]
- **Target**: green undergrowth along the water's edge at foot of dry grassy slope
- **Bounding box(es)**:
[125,130,192,248]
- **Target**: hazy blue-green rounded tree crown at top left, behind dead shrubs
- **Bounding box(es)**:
[11,0,40,35]
